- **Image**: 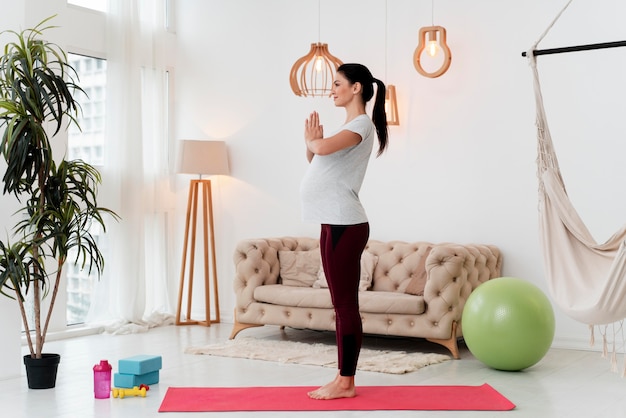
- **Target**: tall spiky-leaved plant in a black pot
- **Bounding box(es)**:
[0,16,117,388]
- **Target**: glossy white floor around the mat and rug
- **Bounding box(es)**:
[0,324,626,418]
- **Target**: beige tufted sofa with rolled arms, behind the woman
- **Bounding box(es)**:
[230,237,502,358]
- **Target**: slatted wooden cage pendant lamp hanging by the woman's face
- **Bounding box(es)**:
[289,0,343,97]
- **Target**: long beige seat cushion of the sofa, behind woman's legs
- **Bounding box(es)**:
[254,284,425,315]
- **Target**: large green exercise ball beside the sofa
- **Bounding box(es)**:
[461,277,554,371]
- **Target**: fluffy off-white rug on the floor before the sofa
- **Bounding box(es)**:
[185,337,451,374]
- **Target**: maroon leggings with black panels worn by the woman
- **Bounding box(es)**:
[320,222,370,376]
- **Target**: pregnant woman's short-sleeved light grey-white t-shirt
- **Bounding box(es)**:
[300,115,376,225]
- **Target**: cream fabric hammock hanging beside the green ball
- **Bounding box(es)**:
[526,0,626,326]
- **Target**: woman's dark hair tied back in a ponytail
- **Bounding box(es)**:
[337,64,389,157]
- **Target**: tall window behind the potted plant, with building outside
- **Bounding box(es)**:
[66,53,107,325]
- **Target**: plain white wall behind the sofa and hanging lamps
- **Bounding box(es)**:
[176,0,626,348]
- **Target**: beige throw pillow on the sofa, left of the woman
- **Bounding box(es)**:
[278,248,321,287]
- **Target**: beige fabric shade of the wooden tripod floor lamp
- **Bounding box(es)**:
[178,139,230,175]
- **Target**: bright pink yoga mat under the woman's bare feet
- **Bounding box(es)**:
[159,383,515,412]
